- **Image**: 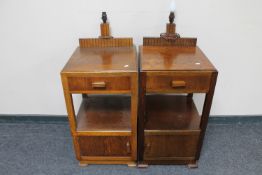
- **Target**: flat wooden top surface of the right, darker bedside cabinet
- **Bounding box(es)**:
[140,46,216,71]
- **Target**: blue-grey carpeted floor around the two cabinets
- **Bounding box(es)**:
[0,122,262,175]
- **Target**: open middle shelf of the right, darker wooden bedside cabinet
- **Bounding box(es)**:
[145,95,200,132]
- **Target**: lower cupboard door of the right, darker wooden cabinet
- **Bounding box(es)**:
[144,132,199,160]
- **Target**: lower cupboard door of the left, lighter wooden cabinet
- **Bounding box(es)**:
[78,136,131,157]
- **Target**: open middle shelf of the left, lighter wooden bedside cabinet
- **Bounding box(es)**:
[77,95,131,133]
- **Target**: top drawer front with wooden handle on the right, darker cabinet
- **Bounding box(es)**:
[146,73,211,93]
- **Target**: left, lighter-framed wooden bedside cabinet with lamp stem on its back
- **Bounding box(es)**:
[61,13,138,166]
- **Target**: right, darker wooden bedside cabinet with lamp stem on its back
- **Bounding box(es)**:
[138,18,218,168]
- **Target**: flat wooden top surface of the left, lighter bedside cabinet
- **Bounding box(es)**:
[62,47,137,73]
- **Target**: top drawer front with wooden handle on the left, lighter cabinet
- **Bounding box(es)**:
[68,77,130,91]
